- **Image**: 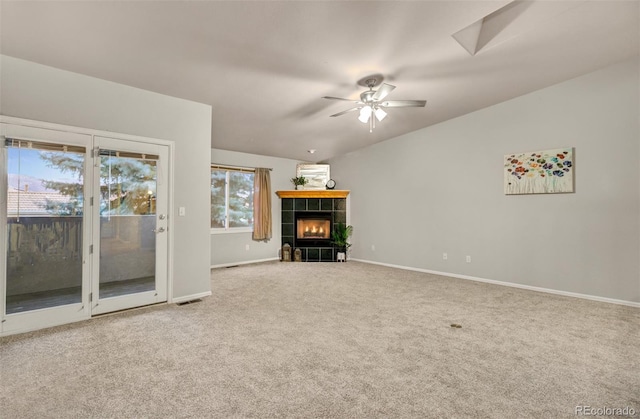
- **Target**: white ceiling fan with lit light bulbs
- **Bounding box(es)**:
[322,78,427,132]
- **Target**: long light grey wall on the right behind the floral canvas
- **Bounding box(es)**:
[330,57,640,302]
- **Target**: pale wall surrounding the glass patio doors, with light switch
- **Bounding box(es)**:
[0,56,211,298]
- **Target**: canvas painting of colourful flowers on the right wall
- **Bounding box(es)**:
[504,147,574,195]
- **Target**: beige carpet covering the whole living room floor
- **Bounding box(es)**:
[0,261,640,418]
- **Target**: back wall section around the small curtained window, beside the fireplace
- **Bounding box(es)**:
[211,149,298,266]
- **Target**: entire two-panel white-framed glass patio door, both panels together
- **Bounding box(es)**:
[0,123,169,334]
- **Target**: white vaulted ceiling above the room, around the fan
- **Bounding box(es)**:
[0,0,640,162]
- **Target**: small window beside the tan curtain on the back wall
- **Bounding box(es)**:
[211,166,254,232]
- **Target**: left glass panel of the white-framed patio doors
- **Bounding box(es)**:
[0,124,91,331]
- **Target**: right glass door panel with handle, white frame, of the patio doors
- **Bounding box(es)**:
[92,137,168,314]
